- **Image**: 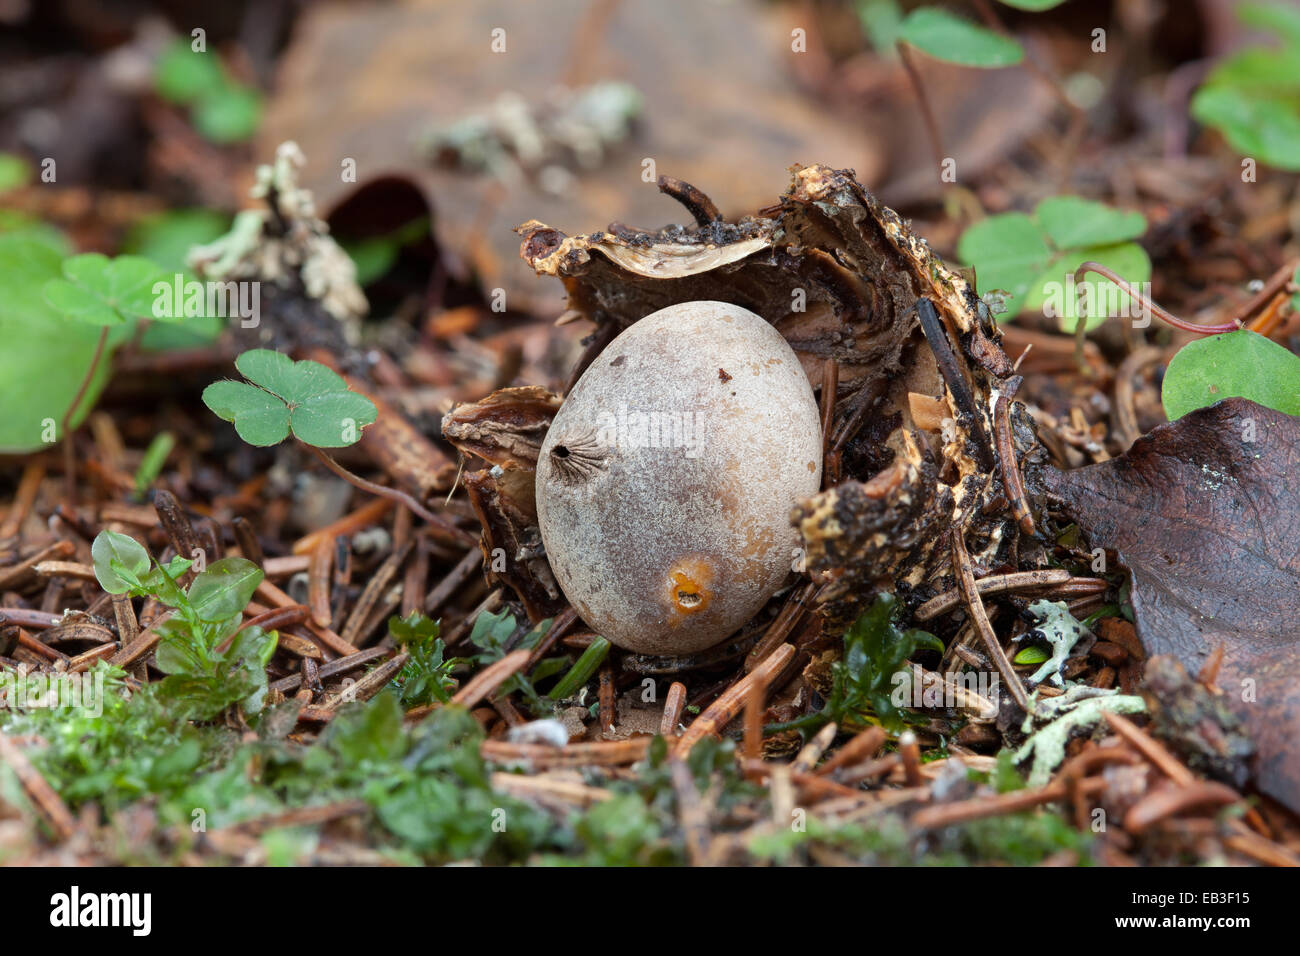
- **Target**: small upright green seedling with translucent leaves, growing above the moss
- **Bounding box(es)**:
[91,531,278,721]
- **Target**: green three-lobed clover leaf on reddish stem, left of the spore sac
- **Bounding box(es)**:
[203,349,378,449]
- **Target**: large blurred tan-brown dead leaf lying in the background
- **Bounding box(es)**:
[260,0,881,313]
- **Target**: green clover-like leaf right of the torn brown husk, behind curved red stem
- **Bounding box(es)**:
[957,196,1151,332]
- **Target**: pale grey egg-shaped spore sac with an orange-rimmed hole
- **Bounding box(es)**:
[537,302,822,654]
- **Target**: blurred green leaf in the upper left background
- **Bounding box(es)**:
[153,40,263,143]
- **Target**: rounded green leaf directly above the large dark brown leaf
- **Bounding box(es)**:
[1161,329,1300,421]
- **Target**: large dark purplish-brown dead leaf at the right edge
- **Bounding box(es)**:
[1044,398,1300,812]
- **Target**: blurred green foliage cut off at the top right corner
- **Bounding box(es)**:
[1191,3,1300,172]
